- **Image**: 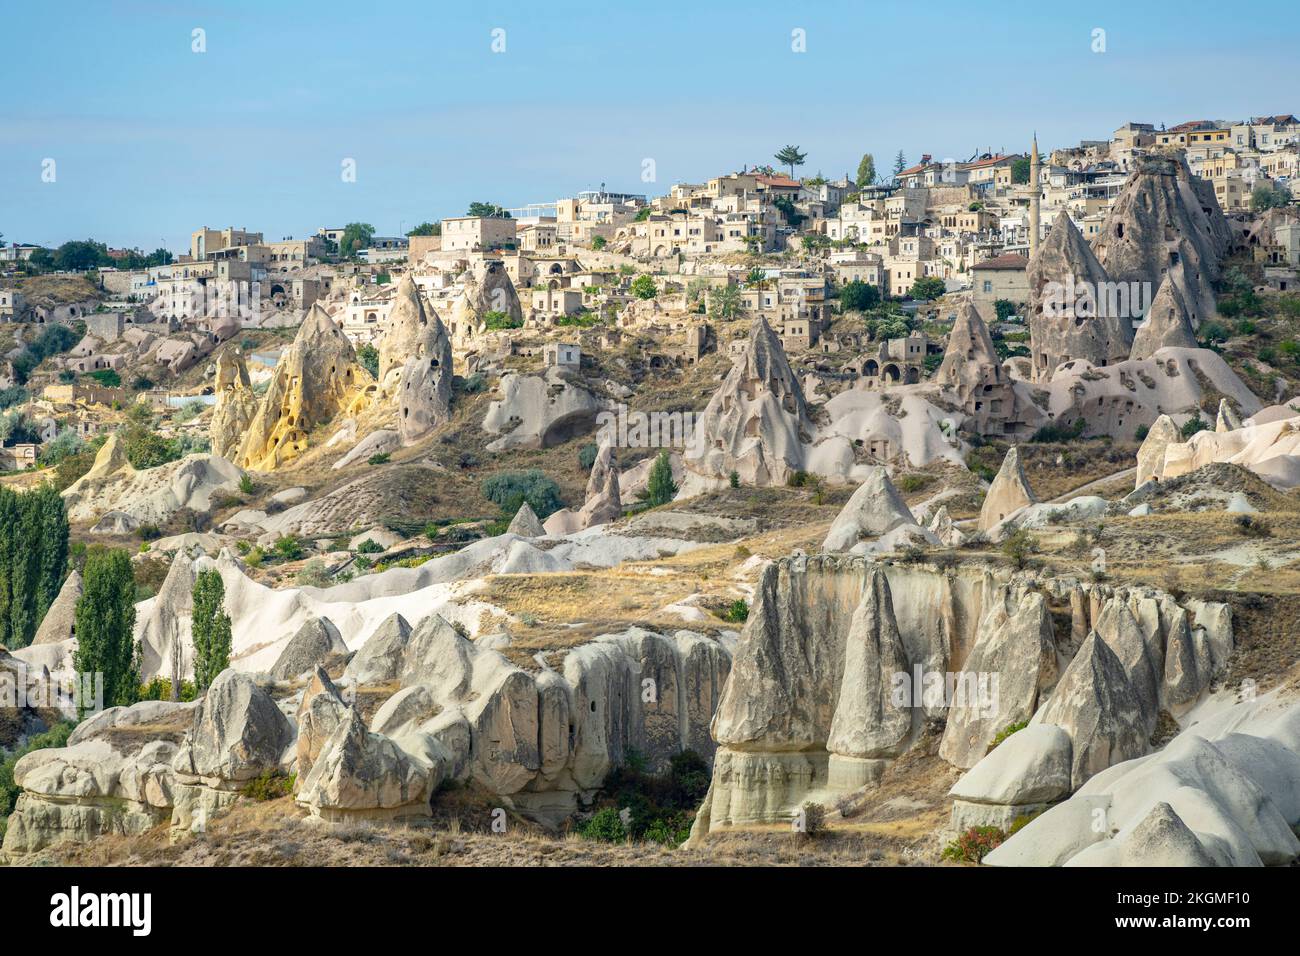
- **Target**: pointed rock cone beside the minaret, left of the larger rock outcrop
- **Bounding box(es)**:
[1027,211,1136,381]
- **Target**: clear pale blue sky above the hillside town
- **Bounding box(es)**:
[0,0,1300,251]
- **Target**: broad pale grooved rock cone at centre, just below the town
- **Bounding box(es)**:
[683,316,813,485]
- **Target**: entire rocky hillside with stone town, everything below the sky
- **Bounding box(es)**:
[0,100,1300,884]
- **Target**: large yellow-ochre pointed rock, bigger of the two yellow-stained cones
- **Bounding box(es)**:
[239,303,374,471]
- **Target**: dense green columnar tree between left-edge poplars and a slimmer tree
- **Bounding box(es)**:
[73,548,140,711]
